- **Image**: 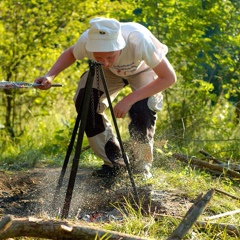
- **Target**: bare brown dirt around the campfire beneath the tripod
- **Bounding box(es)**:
[0,168,191,221]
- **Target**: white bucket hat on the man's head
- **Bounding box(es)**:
[86,18,126,52]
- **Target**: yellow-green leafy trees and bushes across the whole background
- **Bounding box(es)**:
[0,0,239,160]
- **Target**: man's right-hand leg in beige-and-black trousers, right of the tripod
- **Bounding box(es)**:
[128,69,162,178]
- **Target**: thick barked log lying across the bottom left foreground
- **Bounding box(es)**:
[0,217,149,240]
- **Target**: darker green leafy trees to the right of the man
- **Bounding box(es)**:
[131,0,240,150]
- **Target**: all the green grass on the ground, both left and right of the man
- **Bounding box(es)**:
[0,106,240,240]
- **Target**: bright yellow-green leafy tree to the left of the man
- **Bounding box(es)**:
[0,0,135,138]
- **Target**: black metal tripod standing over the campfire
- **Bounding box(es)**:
[53,61,139,218]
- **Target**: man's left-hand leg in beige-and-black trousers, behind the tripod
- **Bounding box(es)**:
[74,70,125,174]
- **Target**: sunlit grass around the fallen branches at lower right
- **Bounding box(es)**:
[101,162,240,240]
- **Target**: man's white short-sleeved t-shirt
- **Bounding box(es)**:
[73,22,168,77]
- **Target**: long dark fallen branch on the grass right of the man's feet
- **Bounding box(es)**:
[173,153,240,179]
